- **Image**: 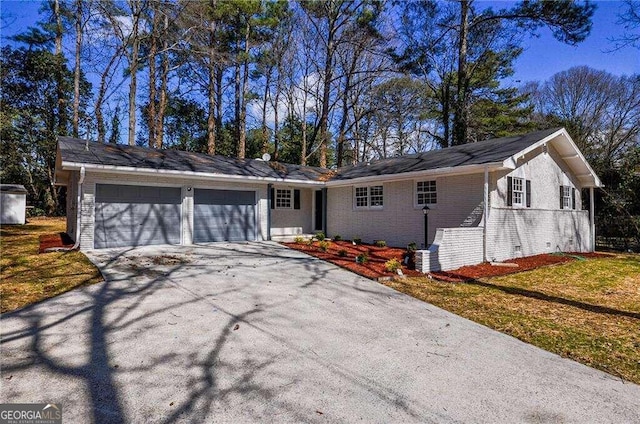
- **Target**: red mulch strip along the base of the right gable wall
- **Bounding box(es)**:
[430,253,610,283]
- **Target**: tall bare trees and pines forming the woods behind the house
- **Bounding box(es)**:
[0,0,640,248]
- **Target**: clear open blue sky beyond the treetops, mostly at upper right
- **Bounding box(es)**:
[0,0,640,85]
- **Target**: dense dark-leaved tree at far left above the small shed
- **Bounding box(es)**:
[0,46,90,214]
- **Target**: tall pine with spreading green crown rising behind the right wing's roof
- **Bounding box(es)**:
[398,0,595,145]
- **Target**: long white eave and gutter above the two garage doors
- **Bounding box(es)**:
[61,161,324,186]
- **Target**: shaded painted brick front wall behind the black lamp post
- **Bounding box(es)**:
[327,173,484,247]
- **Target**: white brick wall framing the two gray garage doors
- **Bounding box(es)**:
[80,171,268,250]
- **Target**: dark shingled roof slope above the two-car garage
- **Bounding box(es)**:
[58,137,331,181]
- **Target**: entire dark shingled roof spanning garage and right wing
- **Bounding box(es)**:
[59,128,560,181]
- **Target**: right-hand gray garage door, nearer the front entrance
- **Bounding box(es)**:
[193,189,256,243]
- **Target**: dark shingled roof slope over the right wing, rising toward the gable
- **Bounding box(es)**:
[332,128,560,181]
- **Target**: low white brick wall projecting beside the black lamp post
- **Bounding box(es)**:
[416,227,483,273]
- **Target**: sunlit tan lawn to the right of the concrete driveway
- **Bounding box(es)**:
[383,254,640,384]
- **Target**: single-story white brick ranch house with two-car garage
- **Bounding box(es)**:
[56,129,601,272]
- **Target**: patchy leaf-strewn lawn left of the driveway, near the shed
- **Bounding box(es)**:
[0,218,102,312]
